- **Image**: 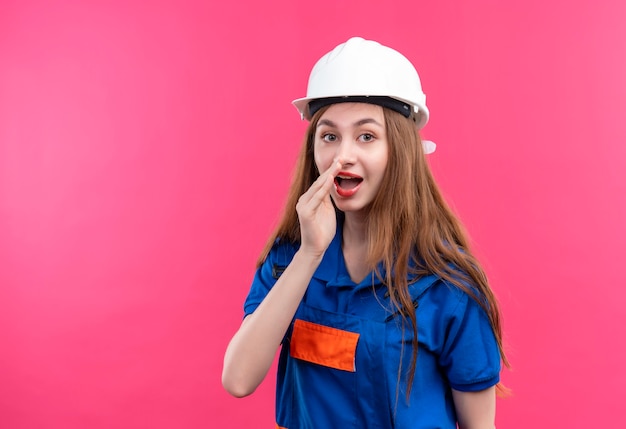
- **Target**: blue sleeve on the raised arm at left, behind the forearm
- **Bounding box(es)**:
[243,240,296,317]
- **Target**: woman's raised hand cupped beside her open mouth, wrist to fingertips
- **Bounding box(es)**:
[296,159,342,257]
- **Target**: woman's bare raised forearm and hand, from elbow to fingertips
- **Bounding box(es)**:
[222,160,342,397]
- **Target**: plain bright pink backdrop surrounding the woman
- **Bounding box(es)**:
[0,0,626,429]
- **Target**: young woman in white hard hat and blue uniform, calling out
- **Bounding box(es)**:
[222,38,506,429]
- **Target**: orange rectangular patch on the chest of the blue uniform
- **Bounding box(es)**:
[289,319,359,372]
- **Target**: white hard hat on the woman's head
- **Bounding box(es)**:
[293,37,435,153]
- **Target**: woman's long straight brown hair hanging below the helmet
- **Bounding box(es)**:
[257,104,509,399]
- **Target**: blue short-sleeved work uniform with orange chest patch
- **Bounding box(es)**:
[244,227,500,429]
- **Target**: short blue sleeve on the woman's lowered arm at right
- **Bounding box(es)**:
[439,286,500,392]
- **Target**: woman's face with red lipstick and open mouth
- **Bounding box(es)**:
[313,103,388,213]
